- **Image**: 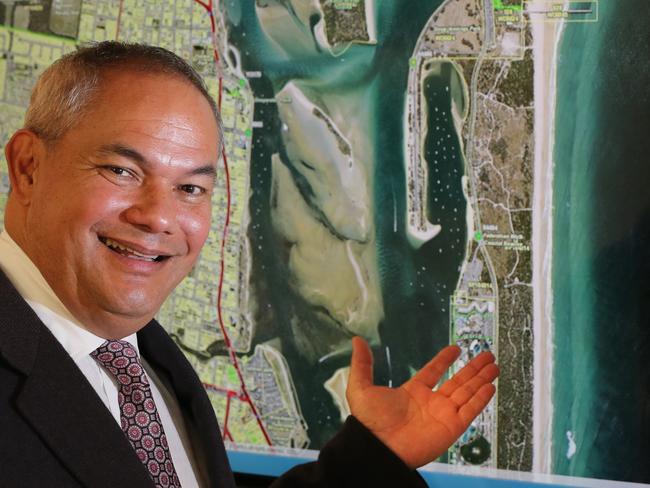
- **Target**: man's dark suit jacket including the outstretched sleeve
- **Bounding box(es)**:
[0,272,426,488]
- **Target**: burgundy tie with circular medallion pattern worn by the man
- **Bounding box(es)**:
[90,341,181,488]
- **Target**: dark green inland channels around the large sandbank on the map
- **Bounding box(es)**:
[225,0,465,448]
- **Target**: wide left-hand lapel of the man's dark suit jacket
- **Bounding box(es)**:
[0,273,152,487]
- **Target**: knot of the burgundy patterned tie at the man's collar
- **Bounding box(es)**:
[90,341,149,386]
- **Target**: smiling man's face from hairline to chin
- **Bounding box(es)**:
[26,70,218,338]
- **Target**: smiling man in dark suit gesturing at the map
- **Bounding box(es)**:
[0,42,498,487]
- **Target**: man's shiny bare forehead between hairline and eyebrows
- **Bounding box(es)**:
[64,69,219,164]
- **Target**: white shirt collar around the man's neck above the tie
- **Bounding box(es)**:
[0,229,139,360]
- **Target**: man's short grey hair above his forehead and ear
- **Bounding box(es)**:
[25,41,223,155]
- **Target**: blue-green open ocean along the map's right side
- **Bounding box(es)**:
[552,0,650,482]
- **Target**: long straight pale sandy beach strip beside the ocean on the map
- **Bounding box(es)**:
[531,0,564,473]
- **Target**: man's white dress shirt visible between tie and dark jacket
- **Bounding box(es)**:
[0,229,200,488]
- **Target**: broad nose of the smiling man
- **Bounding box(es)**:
[123,186,178,234]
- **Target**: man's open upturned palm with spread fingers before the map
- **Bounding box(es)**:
[346,337,499,469]
